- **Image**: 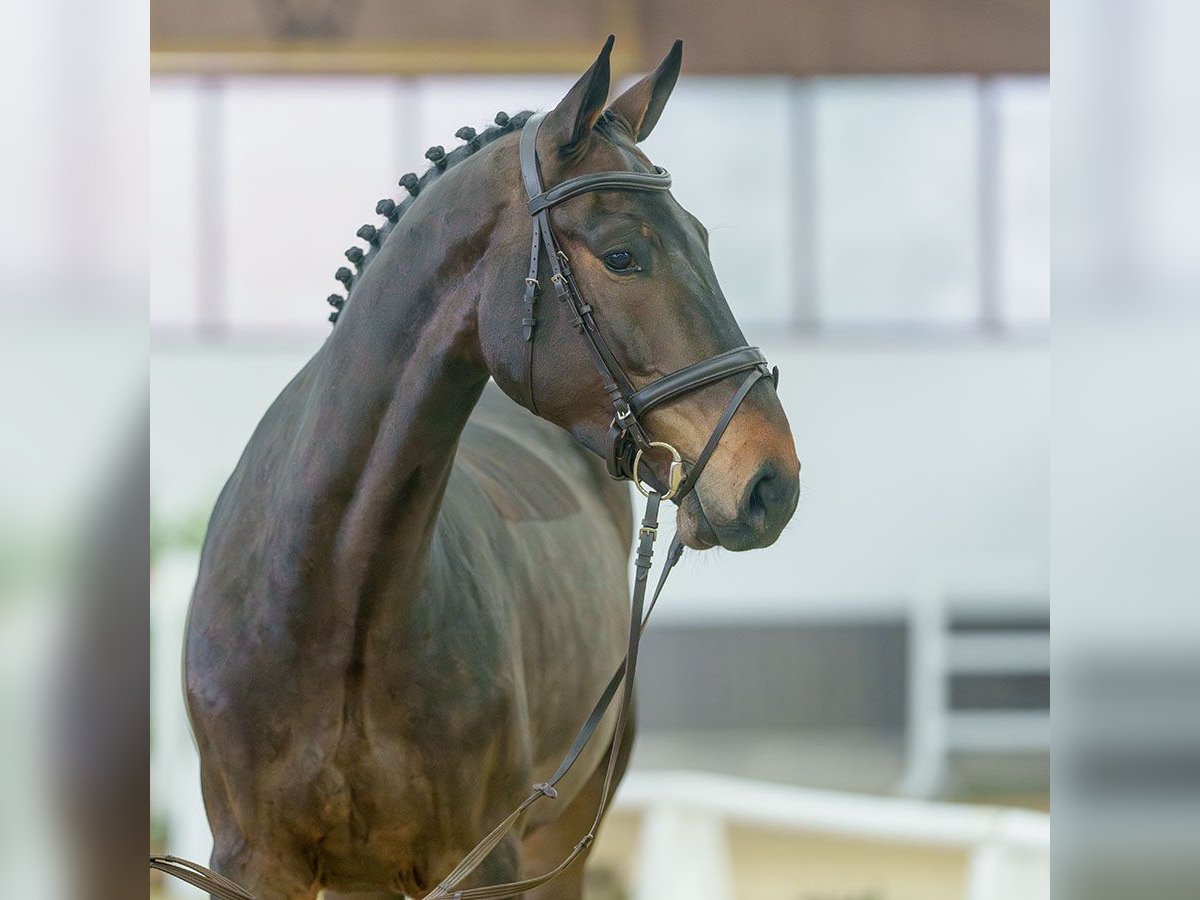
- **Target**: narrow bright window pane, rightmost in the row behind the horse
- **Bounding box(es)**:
[994,78,1050,323]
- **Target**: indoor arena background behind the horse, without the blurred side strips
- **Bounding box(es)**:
[145,0,1050,900]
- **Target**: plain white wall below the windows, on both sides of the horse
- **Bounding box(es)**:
[151,332,1049,617]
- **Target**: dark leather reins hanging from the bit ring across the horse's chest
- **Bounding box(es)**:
[424,491,683,900]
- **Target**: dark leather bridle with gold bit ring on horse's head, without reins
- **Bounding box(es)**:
[521,113,779,503]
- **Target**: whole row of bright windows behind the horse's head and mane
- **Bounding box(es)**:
[151,74,1049,335]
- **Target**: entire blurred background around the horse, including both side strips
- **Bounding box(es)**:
[9,0,1200,900]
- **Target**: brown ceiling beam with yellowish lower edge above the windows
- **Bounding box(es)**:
[150,0,1050,76]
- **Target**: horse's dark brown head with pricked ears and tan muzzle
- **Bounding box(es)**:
[479,38,800,550]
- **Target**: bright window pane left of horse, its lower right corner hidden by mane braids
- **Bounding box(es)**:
[222,78,406,332]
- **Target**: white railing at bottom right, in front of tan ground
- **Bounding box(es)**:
[616,772,1050,900]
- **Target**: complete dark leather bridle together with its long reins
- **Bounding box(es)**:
[150,113,779,900]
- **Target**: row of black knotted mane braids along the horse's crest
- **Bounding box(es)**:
[326,110,533,324]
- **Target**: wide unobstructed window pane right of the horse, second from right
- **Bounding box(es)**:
[814,78,980,325]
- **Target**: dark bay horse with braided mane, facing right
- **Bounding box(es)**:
[185,41,799,900]
